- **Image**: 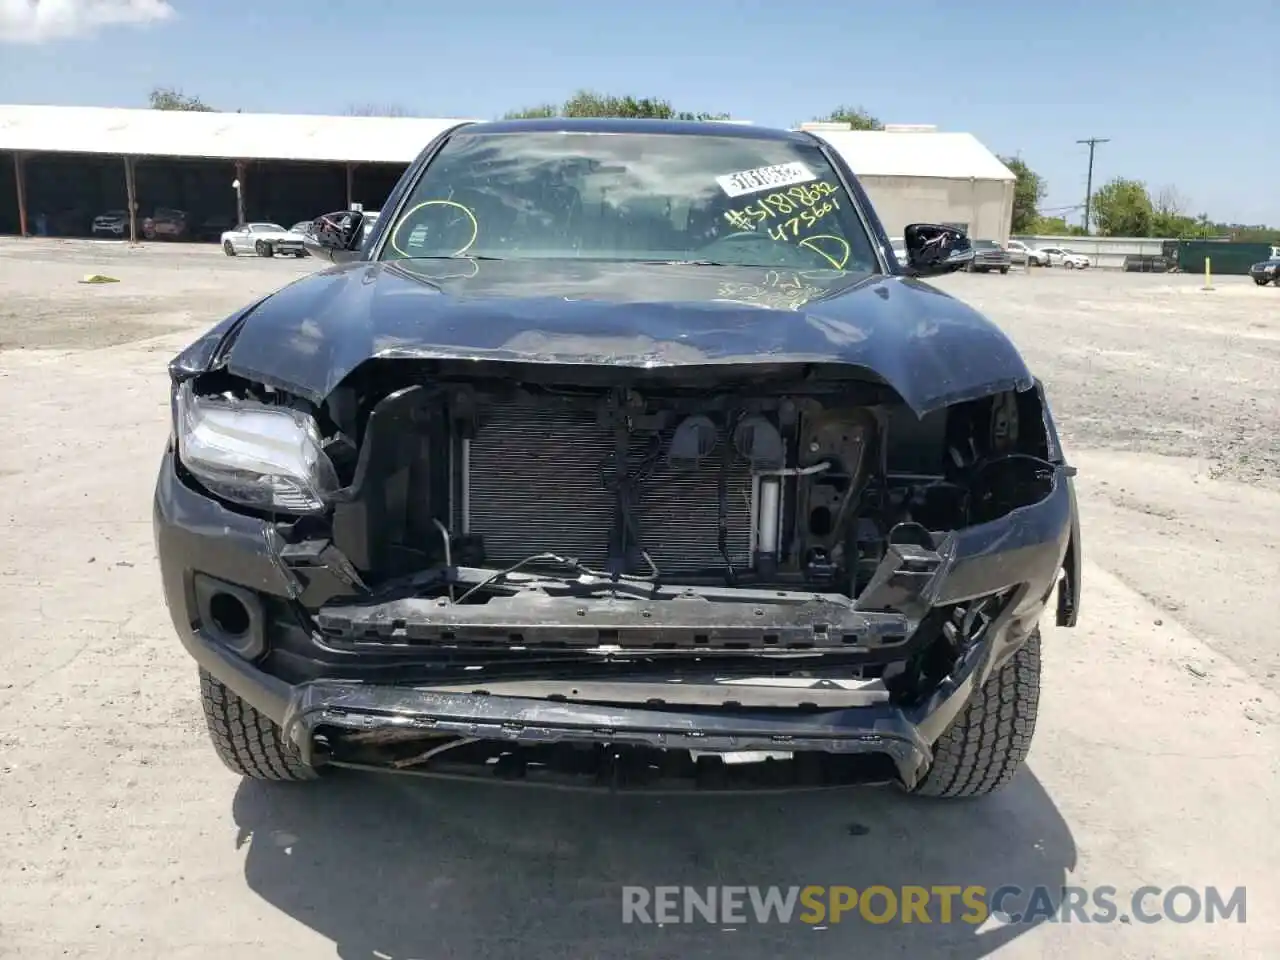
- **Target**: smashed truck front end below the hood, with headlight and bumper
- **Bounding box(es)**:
[155,360,1079,788]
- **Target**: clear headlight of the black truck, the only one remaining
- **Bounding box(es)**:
[174,380,338,513]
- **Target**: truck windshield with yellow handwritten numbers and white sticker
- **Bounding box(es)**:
[379,132,878,273]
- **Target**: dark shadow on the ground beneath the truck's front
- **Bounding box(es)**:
[234,769,1075,960]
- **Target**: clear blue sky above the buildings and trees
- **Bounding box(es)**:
[0,0,1280,225]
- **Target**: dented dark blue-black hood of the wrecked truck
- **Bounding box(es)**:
[218,259,1033,416]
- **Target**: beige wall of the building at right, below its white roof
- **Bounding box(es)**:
[858,175,1014,243]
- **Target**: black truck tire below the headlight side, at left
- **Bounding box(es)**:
[200,669,320,781]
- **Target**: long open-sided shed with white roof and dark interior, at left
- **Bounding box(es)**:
[0,105,478,236]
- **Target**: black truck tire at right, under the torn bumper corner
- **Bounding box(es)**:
[913,627,1041,799]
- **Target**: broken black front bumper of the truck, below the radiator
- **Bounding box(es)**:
[155,456,1079,787]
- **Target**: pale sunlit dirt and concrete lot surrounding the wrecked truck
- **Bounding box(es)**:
[0,239,1280,960]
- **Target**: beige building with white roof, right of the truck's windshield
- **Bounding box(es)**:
[804,124,1016,243]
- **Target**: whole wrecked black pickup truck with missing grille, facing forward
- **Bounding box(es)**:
[155,119,1080,796]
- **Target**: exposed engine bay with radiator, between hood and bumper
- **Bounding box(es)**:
[244,365,1055,603]
